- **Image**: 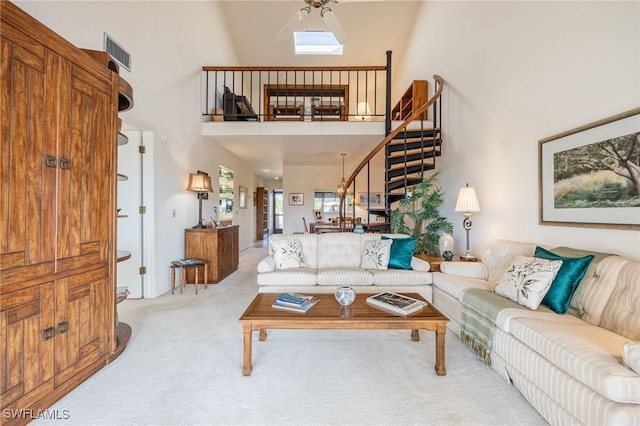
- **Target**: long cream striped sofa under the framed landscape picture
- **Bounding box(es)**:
[432,240,640,425]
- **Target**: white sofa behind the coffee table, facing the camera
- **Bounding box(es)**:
[257,232,432,301]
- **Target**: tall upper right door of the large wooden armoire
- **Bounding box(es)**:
[52,59,115,271]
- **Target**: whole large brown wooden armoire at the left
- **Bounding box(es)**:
[0,1,128,424]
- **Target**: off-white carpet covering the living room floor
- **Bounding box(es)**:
[33,248,546,425]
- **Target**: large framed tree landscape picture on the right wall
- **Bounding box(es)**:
[538,108,640,230]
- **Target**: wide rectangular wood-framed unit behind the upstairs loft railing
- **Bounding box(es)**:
[263,84,349,121]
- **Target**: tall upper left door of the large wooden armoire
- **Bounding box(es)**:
[0,22,56,286]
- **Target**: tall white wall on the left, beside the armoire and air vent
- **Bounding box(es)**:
[16,1,257,297]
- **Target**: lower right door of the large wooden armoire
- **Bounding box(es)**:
[54,268,109,386]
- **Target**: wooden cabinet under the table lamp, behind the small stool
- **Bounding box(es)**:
[184,225,240,284]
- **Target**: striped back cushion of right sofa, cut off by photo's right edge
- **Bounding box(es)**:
[600,258,640,341]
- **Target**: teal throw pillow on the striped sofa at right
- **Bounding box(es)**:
[534,247,595,314]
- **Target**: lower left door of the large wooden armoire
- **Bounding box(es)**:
[0,282,55,409]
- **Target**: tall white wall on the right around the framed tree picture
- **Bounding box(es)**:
[394,2,640,259]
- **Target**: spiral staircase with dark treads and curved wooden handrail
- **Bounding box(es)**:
[339,75,444,232]
